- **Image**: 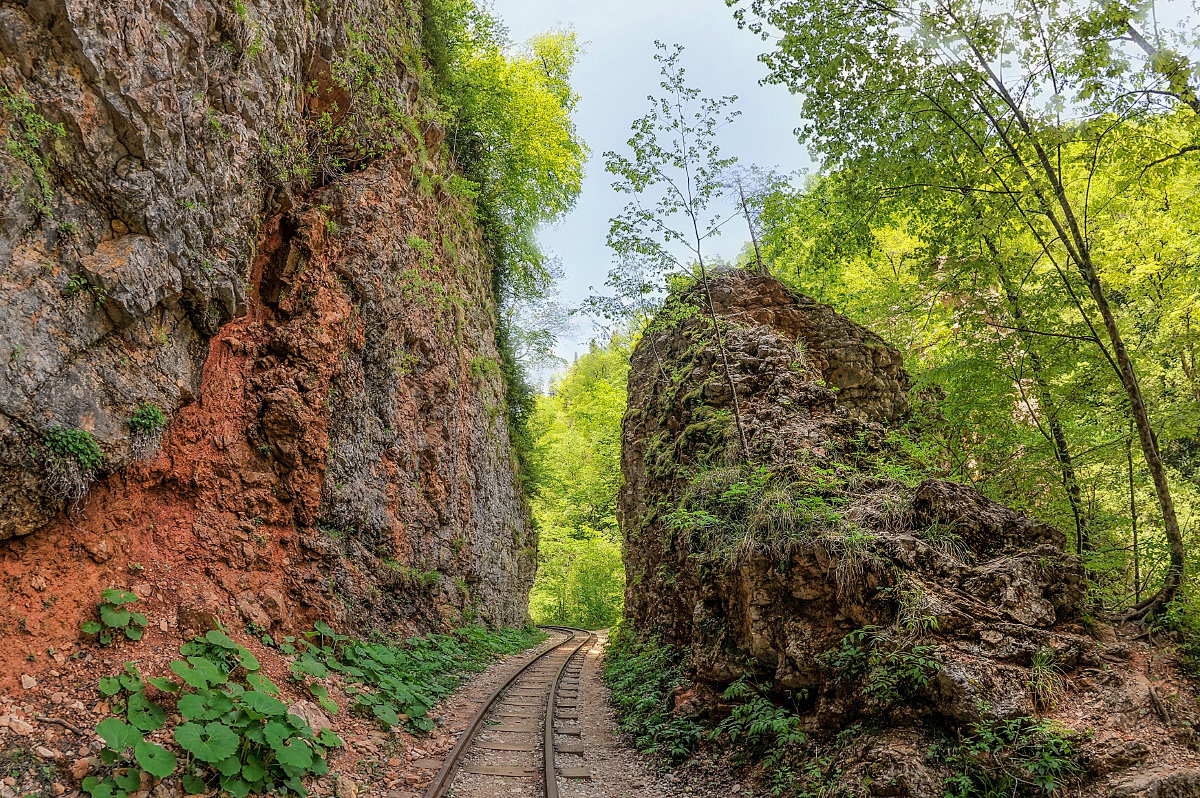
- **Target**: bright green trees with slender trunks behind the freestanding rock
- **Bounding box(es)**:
[730,0,1200,608]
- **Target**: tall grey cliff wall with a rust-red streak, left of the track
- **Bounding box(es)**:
[0,0,535,680]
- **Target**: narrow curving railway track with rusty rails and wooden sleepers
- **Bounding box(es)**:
[424,626,595,798]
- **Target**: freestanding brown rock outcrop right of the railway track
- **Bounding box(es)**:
[620,272,1200,797]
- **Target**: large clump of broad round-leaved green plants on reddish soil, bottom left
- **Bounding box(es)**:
[83,630,341,798]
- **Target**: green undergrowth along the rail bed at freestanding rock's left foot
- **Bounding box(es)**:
[605,628,703,762]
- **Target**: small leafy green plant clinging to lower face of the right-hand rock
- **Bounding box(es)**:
[824,626,942,709]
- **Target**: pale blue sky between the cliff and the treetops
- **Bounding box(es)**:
[492,0,809,361]
